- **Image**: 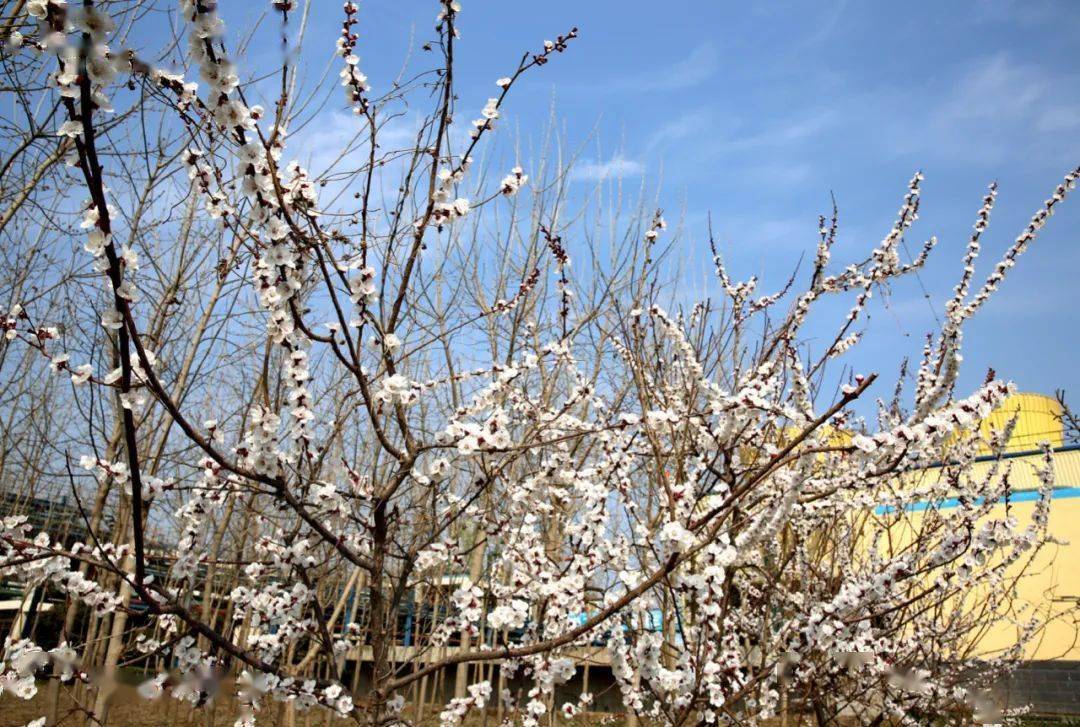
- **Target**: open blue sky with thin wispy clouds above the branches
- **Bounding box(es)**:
[234,0,1080,406]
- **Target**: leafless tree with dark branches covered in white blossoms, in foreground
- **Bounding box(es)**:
[0,0,1080,725]
